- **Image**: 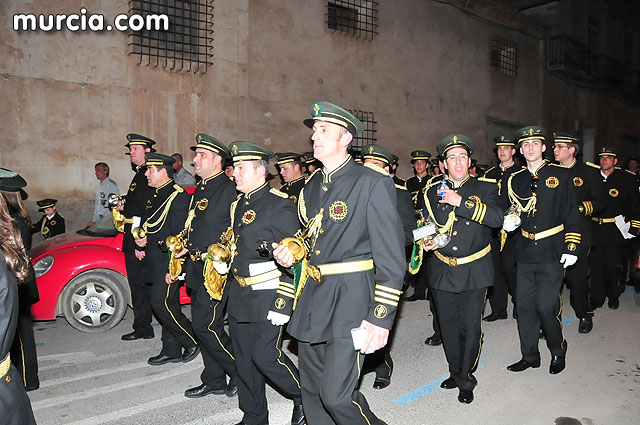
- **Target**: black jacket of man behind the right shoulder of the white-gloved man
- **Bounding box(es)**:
[567,161,604,247]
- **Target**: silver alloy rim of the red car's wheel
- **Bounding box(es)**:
[72,282,115,326]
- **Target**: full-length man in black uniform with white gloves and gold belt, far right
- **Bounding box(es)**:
[503,126,581,374]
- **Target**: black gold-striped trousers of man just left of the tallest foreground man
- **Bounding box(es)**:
[229,317,306,425]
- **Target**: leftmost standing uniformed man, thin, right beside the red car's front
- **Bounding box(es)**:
[118,133,156,341]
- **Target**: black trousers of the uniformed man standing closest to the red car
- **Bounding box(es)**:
[124,251,153,336]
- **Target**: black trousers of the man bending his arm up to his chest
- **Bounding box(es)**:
[431,288,487,390]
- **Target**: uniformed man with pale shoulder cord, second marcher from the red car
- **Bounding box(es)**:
[134,152,200,366]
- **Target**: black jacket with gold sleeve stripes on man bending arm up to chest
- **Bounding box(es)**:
[423,176,503,293]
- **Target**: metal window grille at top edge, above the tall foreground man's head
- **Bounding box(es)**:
[326,0,378,40]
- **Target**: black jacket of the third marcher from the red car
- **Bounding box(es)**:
[185,171,236,288]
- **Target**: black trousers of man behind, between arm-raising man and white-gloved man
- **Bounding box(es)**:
[489,235,516,315]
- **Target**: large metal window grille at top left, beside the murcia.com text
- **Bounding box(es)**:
[129,0,213,73]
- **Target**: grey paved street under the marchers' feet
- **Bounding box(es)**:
[29,288,640,425]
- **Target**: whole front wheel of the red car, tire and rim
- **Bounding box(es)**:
[58,269,129,332]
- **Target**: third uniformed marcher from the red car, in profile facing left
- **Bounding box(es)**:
[183,133,237,398]
